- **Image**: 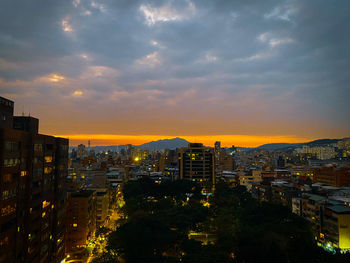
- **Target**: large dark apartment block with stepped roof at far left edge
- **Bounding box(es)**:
[0,97,68,263]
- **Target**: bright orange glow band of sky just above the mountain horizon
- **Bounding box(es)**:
[55,134,312,147]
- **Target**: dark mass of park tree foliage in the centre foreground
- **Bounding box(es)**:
[95,178,349,263]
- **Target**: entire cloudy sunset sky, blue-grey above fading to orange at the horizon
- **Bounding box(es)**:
[0,0,350,146]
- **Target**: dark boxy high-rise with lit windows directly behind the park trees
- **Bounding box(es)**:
[179,143,215,186]
